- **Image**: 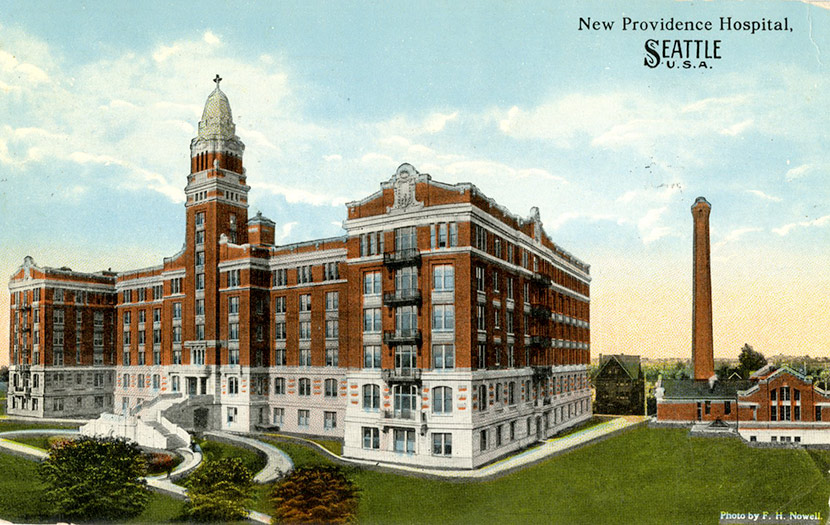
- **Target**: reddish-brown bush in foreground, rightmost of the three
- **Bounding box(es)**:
[271,466,360,523]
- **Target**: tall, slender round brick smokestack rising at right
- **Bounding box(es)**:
[692,197,715,381]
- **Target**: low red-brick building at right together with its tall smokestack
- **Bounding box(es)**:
[655,197,830,444]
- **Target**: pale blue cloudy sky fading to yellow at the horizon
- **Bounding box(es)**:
[0,0,830,363]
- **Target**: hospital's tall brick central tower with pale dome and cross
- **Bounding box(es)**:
[182,75,250,364]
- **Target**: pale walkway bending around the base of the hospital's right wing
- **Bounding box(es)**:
[280,416,649,480]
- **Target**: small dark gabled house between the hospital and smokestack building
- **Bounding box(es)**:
[594,355,645,415]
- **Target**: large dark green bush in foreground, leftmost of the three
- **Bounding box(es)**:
[40,437,149,520]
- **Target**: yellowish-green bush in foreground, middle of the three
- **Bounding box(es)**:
[185,458,254,521]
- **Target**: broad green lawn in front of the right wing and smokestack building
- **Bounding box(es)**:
[261,428,830,524]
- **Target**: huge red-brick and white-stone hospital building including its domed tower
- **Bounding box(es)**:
[8,82,591,468]
